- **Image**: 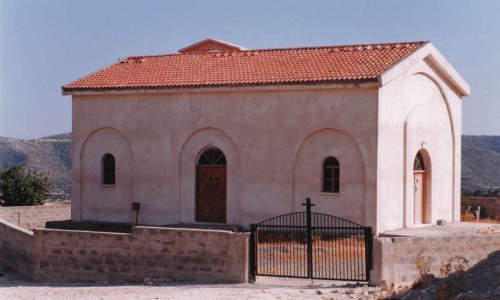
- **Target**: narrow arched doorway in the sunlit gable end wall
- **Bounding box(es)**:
[413,151,427,224]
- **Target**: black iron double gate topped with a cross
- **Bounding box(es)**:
[250,198,372,281]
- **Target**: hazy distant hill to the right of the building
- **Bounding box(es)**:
[462,135,500,190]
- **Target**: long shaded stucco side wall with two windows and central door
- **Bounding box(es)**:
[72,86,378,230]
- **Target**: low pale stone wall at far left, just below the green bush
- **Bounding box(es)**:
[0,204,71,230]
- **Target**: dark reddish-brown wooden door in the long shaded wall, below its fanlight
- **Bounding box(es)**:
[196,166,227,223]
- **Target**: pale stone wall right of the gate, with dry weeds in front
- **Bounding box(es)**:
[371,234,500,284]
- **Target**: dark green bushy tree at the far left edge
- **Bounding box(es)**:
[0,165,52,206]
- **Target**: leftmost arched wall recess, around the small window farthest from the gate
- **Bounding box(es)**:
[80,127,134,222]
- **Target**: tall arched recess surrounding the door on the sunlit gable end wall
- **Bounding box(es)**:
[402,73,456,227]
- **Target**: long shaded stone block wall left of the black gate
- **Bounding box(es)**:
[0,222,248,282]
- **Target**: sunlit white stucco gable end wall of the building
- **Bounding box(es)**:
[377,59,462,232]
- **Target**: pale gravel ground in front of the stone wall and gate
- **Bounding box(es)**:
[0,271,387,300]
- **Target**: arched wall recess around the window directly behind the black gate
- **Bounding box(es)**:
[291,128,367,224]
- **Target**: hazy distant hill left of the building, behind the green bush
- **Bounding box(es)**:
[0,133,71,199]
